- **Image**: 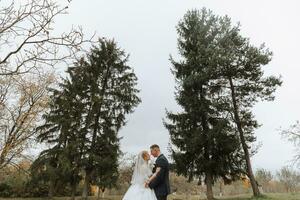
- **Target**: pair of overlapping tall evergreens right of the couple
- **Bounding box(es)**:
[166,9,281,198]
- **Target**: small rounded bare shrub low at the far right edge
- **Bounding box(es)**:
[277,167,300,192]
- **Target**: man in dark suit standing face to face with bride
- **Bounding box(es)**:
[146,144,170,200]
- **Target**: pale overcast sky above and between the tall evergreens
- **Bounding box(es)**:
[57,0,300,170]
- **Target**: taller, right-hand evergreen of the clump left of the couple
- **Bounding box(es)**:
[69,39,140,198]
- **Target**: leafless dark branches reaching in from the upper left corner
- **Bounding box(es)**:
[0,0,90,75]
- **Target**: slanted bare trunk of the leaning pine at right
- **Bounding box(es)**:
[229,78,261,197]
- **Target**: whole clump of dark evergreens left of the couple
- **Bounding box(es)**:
[33,39,140,195]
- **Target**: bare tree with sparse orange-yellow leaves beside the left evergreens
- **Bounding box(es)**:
[0,73,55,169]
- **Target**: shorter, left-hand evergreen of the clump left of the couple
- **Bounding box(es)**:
[31,80,83,196]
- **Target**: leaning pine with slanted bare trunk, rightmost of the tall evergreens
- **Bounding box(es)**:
[216,17,281,196]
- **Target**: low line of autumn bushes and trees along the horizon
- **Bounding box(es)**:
[0,156,300,199]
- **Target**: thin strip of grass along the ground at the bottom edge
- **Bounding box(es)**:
[0,193,300,200]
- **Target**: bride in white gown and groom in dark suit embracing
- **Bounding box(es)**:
[123,144,170,200]
